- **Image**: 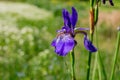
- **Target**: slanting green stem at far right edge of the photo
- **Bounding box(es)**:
[110,30,120,80]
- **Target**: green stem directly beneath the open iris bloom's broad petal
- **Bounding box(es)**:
[70,49,76,80]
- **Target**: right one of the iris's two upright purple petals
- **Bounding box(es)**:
[71,7,78,29]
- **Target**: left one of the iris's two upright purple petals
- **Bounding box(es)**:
[62,9,71,27]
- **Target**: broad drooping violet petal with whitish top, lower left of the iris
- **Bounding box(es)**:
[55,34,75,56]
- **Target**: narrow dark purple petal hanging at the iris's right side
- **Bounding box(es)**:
[84,36,97,52]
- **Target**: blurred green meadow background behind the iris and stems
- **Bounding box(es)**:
[0,0,120,80]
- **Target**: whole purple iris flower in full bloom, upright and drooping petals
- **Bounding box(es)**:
[51,7,97,56]
